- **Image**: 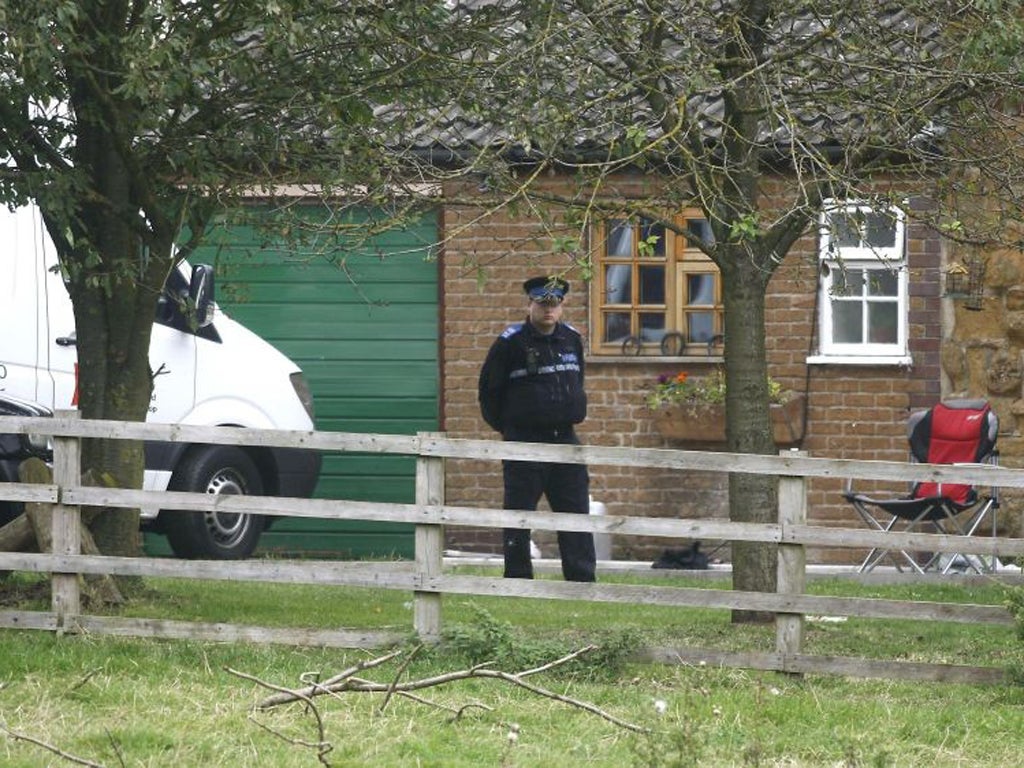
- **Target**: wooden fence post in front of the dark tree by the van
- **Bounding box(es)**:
[50,411,82,632]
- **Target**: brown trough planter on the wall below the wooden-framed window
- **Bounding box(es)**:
[653,394,804,445]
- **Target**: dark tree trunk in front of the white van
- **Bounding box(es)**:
[56,109,173,557]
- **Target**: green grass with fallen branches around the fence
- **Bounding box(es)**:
[0,574,1024,768]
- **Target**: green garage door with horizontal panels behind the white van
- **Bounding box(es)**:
[190,206,440,557]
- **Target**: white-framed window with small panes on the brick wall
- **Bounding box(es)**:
[811,201,908,362]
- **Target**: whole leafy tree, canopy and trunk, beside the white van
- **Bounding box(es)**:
[0,0,487,554]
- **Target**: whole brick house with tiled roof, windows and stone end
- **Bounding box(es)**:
[354,7,1024,573]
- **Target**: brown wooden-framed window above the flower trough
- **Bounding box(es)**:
[591,213,723,356]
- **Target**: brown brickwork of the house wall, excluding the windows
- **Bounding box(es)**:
[442,182,942,562]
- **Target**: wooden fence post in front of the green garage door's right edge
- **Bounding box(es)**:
[413,432,444,642]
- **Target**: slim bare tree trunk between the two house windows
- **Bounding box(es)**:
[722,246,778,622]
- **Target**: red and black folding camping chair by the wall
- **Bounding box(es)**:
[843,399,999,573]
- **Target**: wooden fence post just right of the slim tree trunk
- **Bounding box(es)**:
[775,451,807,667]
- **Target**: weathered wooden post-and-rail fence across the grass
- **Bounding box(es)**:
[0,412,1024,682]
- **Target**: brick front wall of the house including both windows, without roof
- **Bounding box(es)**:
[441,179,966,561]
